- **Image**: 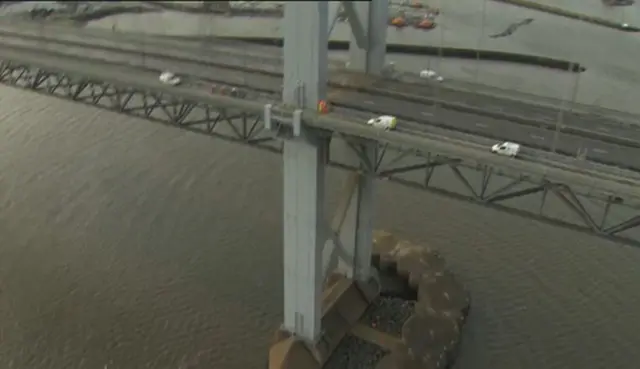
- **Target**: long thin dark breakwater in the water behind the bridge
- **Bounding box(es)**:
[222,37,587,73]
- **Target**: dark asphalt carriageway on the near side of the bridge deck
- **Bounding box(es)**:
[2,25,640,171]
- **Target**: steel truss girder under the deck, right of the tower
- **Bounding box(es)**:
[351,139,640,245]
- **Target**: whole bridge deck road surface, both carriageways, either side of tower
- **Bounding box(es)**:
[5,23,640,169]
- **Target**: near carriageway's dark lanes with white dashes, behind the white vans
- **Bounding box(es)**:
[0,33,636,168]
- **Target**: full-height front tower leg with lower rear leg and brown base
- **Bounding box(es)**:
[265,1,378,369]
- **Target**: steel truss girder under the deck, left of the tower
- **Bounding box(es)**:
[0,62,281,151]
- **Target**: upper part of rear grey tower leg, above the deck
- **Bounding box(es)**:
[343,0,389,74]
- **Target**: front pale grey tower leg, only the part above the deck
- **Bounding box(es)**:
[282,1,329,110]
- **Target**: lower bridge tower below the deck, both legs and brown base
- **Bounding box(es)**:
[269,134,380,369]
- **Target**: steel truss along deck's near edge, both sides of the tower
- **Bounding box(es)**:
[0,62,640,245]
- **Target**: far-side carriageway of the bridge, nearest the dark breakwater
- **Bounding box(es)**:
[0,23,636,127]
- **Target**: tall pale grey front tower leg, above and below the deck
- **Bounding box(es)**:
[283,1,329,342]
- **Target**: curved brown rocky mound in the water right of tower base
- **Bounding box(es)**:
[373,231,470,369]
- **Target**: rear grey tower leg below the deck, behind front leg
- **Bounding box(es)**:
[336,142,377,281]
